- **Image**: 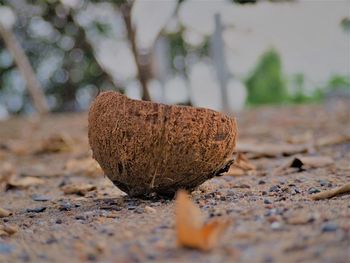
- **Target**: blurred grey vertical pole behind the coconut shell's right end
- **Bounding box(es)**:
[211,14,230,113]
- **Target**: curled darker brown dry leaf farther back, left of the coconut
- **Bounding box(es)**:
[34,133,73,154]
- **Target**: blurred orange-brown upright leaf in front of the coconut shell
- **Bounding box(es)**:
[175,190,229,251]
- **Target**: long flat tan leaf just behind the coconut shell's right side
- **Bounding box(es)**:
[236,142,310,158]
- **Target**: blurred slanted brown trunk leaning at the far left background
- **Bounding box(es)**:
[0,24,49,114]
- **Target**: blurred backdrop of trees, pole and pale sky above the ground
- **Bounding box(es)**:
[0,0,350,119]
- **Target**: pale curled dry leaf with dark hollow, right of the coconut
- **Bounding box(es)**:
[273,156,334,175]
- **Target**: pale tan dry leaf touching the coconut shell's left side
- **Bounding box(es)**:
[65,158,103,176]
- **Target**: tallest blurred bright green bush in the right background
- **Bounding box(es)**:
[246,49,288,105]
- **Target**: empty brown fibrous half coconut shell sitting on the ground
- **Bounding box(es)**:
[89,92,237,197]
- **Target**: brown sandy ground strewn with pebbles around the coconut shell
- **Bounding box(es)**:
[0,100,350,262]
